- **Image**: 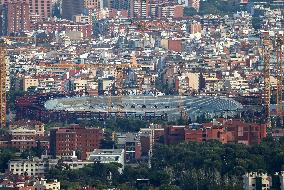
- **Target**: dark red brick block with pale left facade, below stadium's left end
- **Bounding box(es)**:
[50,125,103,159]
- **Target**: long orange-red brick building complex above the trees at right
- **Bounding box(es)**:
[165,119,266,145]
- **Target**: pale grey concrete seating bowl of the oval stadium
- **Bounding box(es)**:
[45,95,242,119]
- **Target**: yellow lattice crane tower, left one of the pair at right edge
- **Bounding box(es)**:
[263,36,271,127]
